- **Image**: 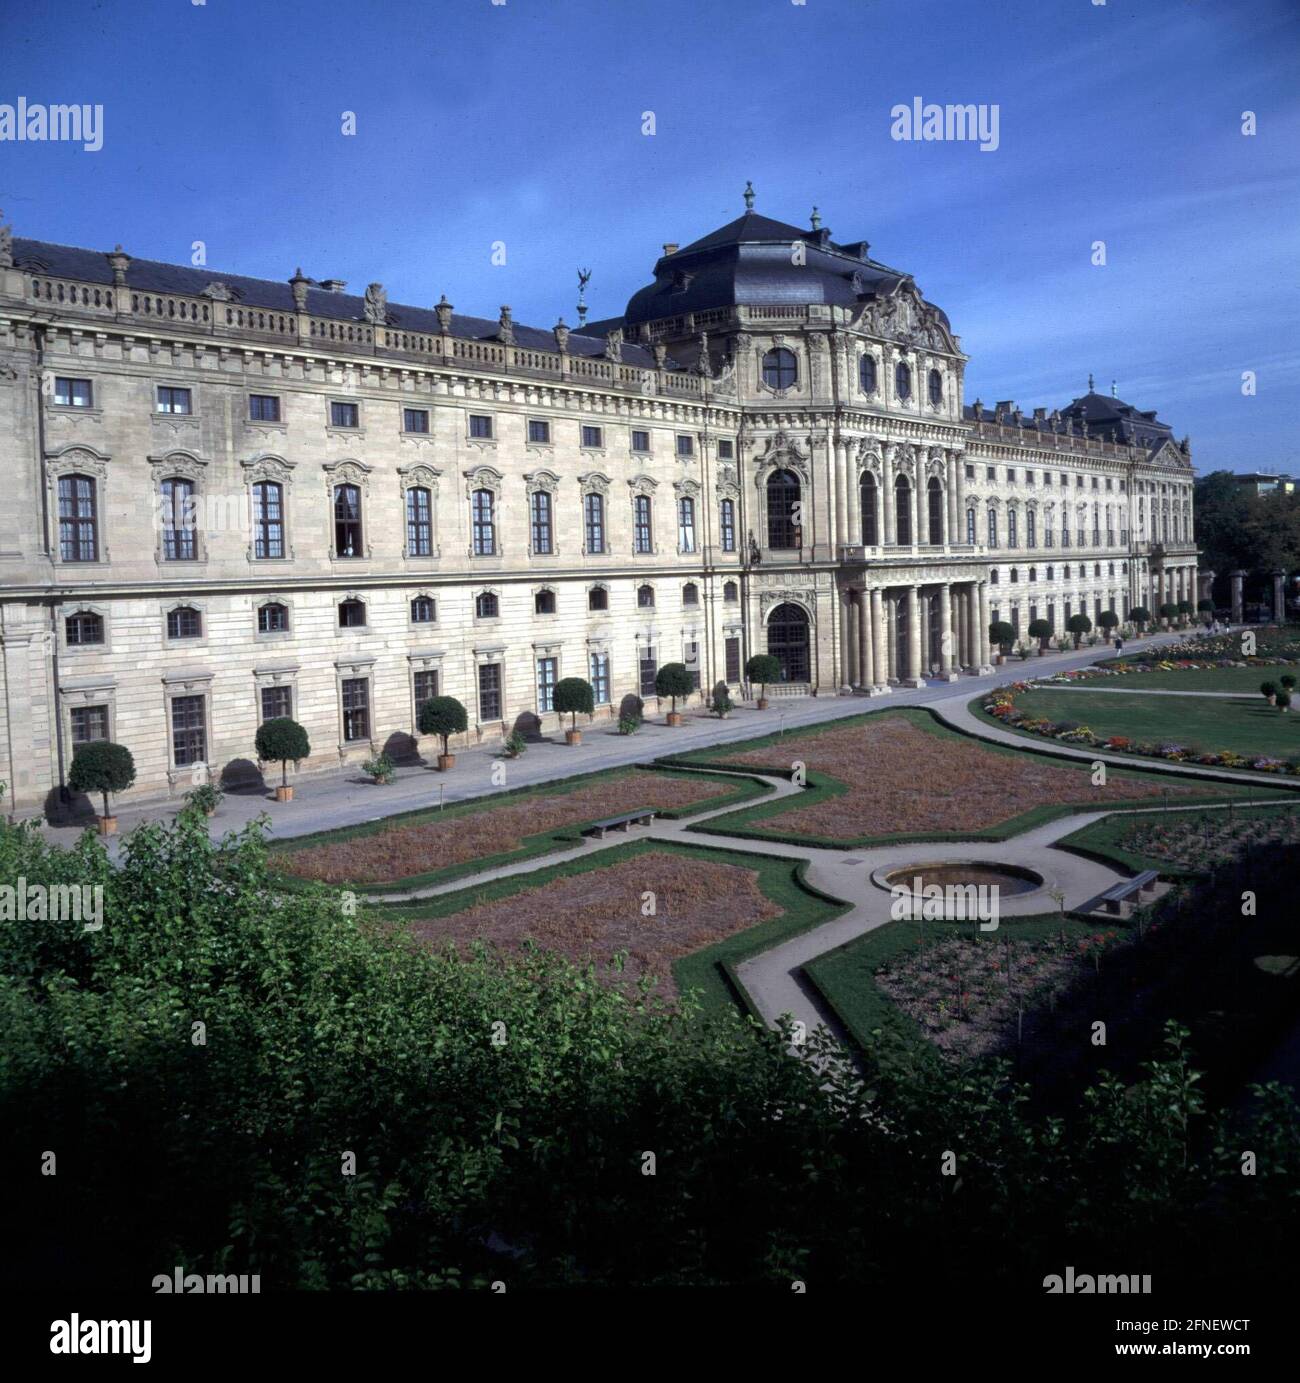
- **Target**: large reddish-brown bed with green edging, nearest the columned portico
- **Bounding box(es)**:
[669,693,1277,849]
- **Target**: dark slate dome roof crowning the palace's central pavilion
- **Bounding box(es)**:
[622,212,949,328]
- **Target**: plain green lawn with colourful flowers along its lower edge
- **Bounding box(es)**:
[1011,688,1300,758]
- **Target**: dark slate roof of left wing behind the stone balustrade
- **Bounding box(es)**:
[14,235,678,369]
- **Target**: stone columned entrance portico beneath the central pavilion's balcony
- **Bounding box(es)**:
[839,578,992,694]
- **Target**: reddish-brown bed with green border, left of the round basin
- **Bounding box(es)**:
[372,841,848,1012]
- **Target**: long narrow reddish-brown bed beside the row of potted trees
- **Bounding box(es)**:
[272,768,769,892]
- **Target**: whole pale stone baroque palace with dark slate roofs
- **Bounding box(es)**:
[0,189,1198,810]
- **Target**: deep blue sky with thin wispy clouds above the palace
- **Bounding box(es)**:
[0,0,1300,470]
